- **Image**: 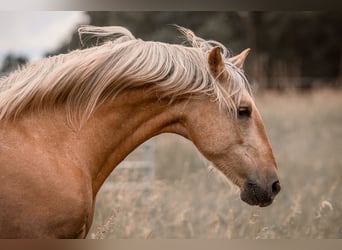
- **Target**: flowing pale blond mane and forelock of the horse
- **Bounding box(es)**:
[0,26,250,125]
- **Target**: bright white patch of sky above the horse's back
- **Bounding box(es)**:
[0,11,89,65]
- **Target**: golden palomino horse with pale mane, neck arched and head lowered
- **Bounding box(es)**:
[0,26,280,238]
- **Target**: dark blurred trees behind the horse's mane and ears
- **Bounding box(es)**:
[2,12,342,90]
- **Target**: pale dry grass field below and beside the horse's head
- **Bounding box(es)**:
[88,89,342,239]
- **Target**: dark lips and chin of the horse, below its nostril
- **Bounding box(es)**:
[240,183,275,207]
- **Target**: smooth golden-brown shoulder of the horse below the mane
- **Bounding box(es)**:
[0,127,94,238]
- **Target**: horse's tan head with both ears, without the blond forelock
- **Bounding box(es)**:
[185,46,280,206]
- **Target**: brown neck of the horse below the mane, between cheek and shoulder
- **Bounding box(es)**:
[80,90,186,194]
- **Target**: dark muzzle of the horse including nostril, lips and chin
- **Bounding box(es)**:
[240,180,281,207]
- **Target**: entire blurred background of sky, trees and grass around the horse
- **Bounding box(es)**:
[0,11,342,239]
